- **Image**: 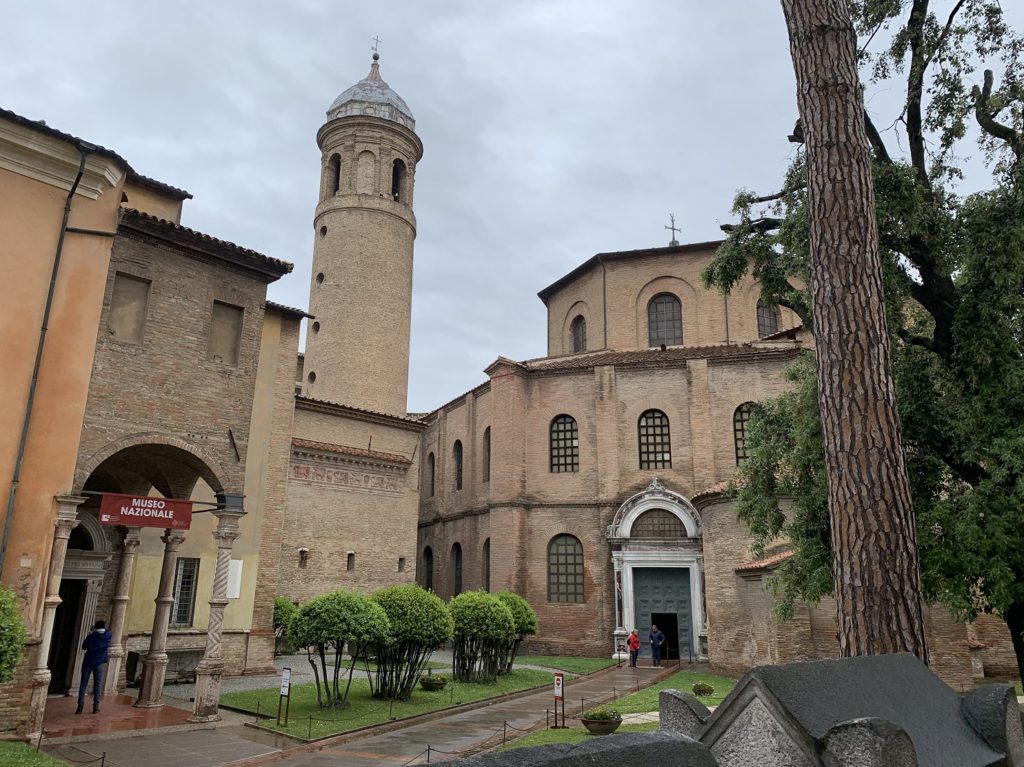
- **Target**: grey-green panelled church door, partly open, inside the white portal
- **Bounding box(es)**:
[633,567,693,659]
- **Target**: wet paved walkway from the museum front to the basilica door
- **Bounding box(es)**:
[44,668,675,767]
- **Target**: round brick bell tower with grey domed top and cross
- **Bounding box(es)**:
[302,52,423,415]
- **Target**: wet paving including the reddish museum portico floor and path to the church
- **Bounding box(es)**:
[43,658,676,767]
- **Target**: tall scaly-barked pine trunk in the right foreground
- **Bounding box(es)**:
[782,0,927,662]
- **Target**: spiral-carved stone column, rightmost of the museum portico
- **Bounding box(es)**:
[188,493,246,722]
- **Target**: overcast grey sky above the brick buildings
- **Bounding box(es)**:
[6,0,1022,411]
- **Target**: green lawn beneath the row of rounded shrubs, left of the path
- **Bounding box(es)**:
[223,669,551,737]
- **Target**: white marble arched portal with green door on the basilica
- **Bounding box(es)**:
[606,477,708,658]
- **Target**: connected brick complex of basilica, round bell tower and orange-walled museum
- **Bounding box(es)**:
[0,54,1016,734]
